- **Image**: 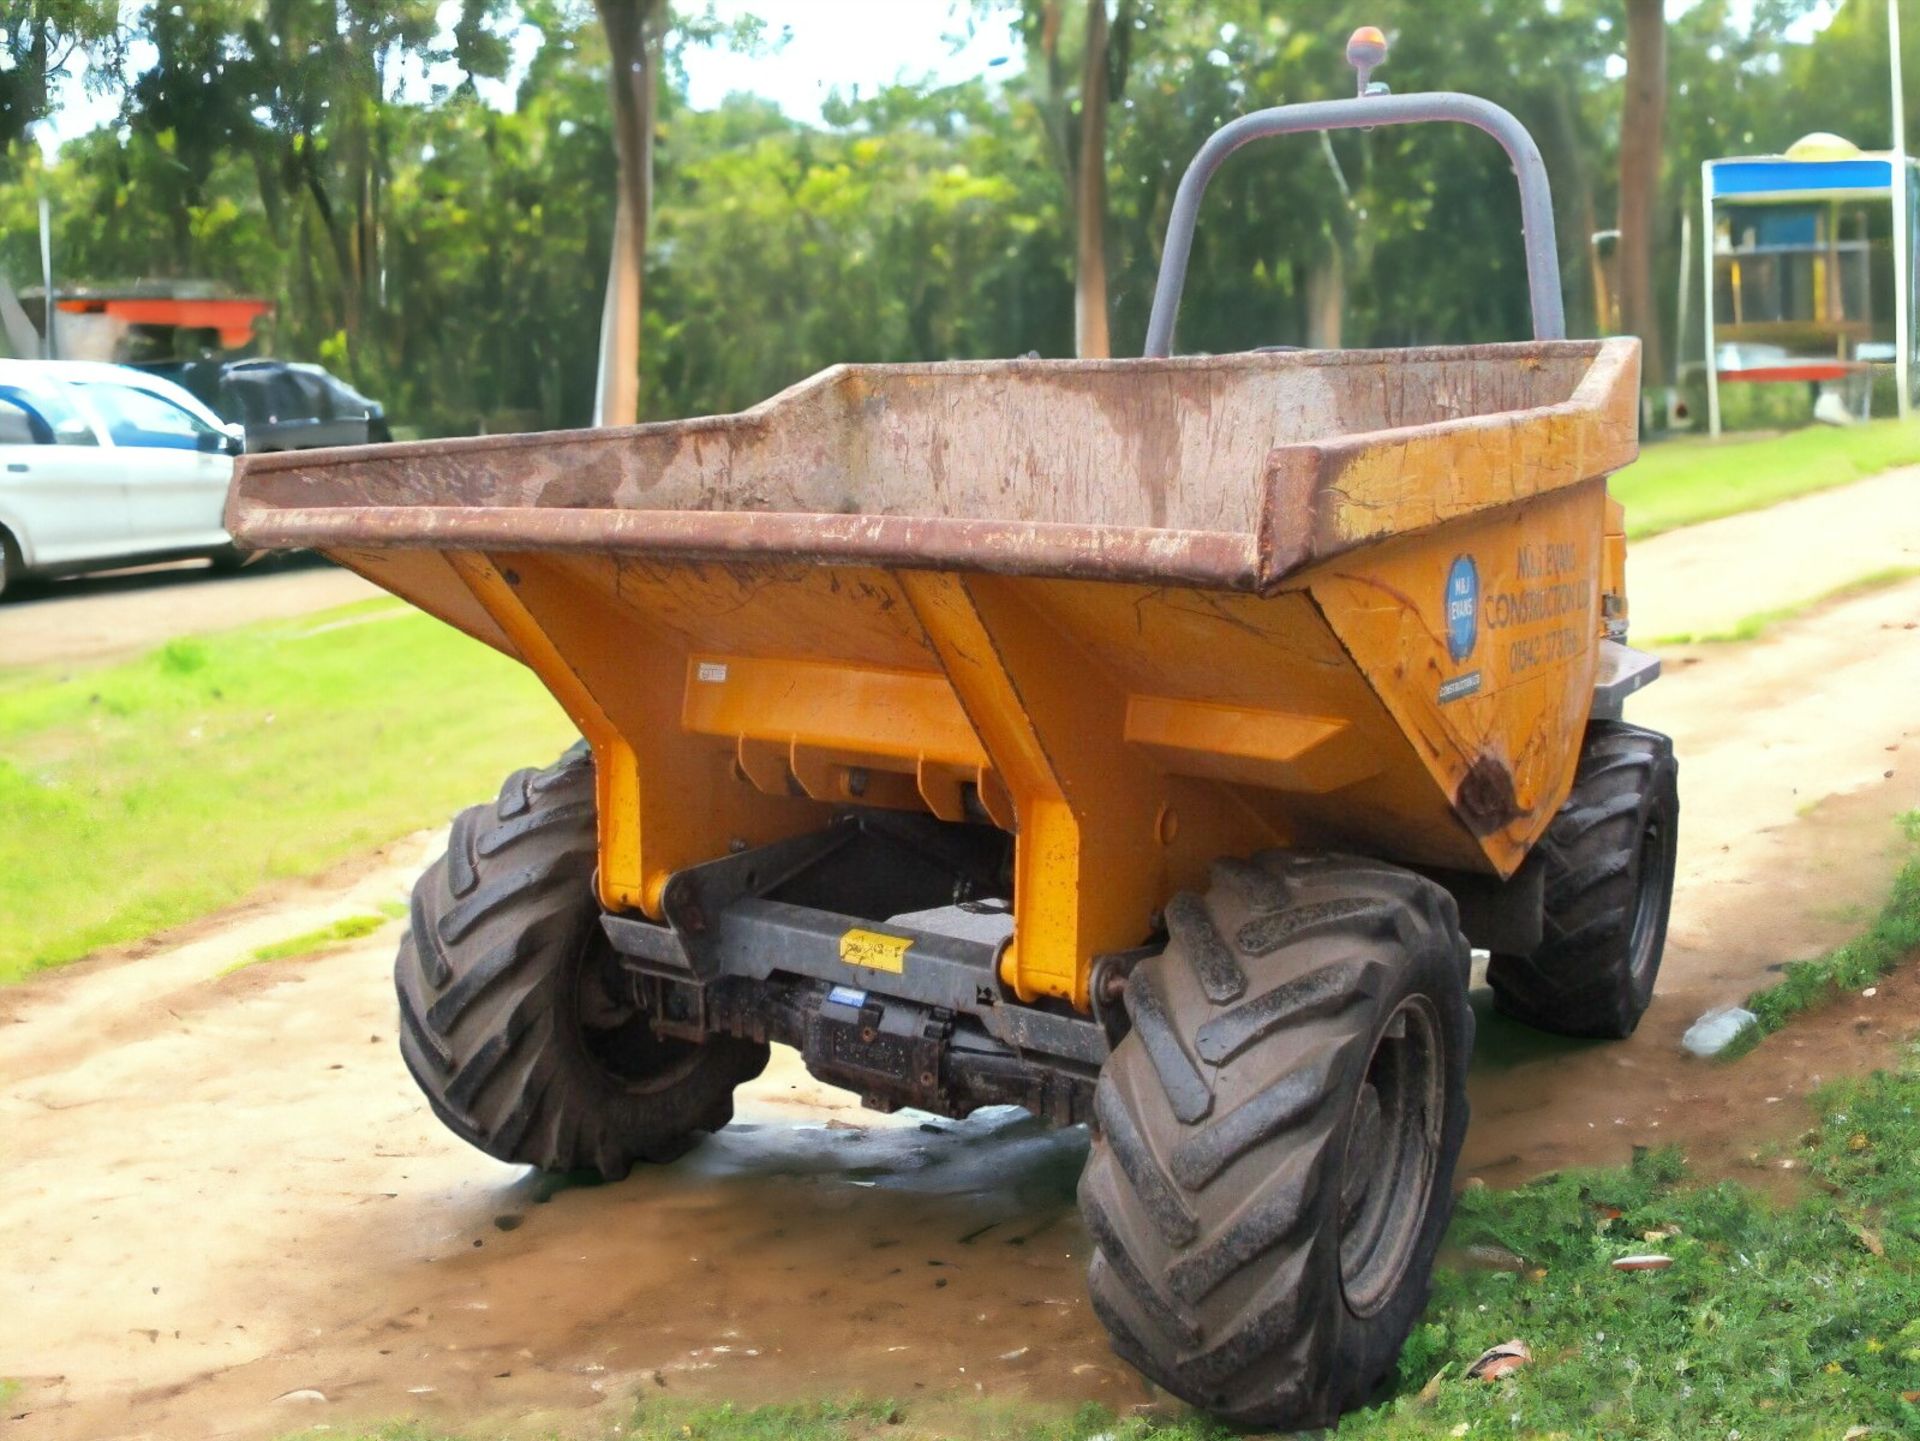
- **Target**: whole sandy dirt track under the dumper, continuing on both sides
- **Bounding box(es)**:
[0,487,1920,1441]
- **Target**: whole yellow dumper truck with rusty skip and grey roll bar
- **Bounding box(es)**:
[230,33,1678,1426]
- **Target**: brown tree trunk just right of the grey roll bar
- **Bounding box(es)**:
[1619,0,1667,388]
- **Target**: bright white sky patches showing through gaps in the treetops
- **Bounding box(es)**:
[38,0,1020,155]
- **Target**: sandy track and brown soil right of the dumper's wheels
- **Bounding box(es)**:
[1463,581,1920,1184]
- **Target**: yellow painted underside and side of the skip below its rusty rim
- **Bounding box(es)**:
[366,495,1605,1005]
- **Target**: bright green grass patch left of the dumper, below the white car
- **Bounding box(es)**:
[0,601,572,982]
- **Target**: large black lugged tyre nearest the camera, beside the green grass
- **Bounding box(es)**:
[1079,852,1473,1428]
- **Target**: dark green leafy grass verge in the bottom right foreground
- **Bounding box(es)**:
[274,1050,1920,1441]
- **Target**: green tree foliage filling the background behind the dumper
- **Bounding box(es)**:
[0,0,1881,432]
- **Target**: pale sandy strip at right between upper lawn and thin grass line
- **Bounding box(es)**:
[1626,466,1920,641]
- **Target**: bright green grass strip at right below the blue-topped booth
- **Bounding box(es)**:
[1609,420,1920,539]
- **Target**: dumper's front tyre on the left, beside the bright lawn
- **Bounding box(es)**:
[394,746,768,1180]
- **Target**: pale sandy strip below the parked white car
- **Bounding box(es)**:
[0,556,380,666]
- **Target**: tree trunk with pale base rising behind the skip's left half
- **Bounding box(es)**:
[593,0,666,426]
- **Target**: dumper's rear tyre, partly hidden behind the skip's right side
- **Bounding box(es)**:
[1486,721,1680,1040]
